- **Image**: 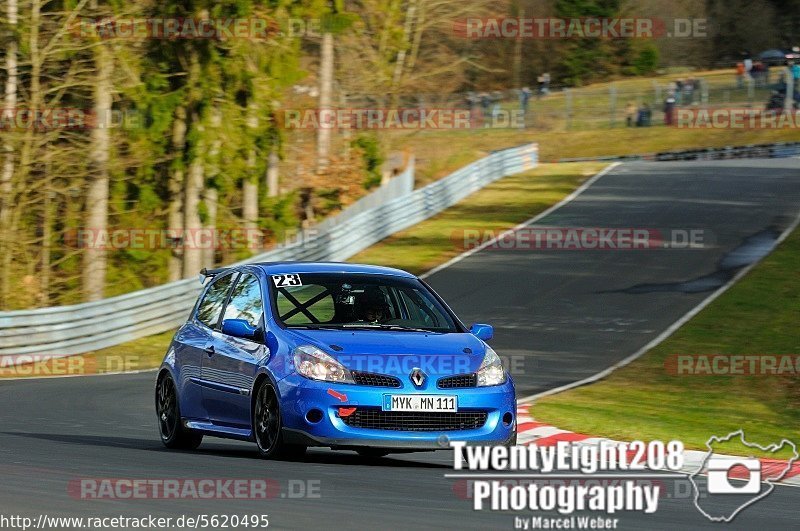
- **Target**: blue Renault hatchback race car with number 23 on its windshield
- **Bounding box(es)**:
[155,262,516,458]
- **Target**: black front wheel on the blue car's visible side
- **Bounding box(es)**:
[252,381,306,460]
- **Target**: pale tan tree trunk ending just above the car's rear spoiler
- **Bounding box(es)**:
[183,115,205,278]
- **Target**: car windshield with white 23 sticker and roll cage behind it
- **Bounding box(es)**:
[270,273,461,333]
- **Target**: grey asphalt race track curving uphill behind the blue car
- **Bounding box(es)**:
[0,159,800,529]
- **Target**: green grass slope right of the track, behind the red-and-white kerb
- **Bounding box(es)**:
[531,230,800,458]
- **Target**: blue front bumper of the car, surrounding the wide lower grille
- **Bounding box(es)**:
[278,374,517,450]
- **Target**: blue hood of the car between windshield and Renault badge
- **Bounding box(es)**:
[290,330,486,375]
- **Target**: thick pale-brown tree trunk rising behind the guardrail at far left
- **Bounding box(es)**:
[82,43,114,301]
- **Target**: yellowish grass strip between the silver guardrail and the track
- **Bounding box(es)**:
[0,162,606,378]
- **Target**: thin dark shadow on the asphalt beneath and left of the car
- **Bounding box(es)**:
[0,431,451,468]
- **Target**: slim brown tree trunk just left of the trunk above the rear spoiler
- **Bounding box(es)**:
[167,107,186,282]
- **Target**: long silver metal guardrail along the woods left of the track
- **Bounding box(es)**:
[0,144,538,356]
